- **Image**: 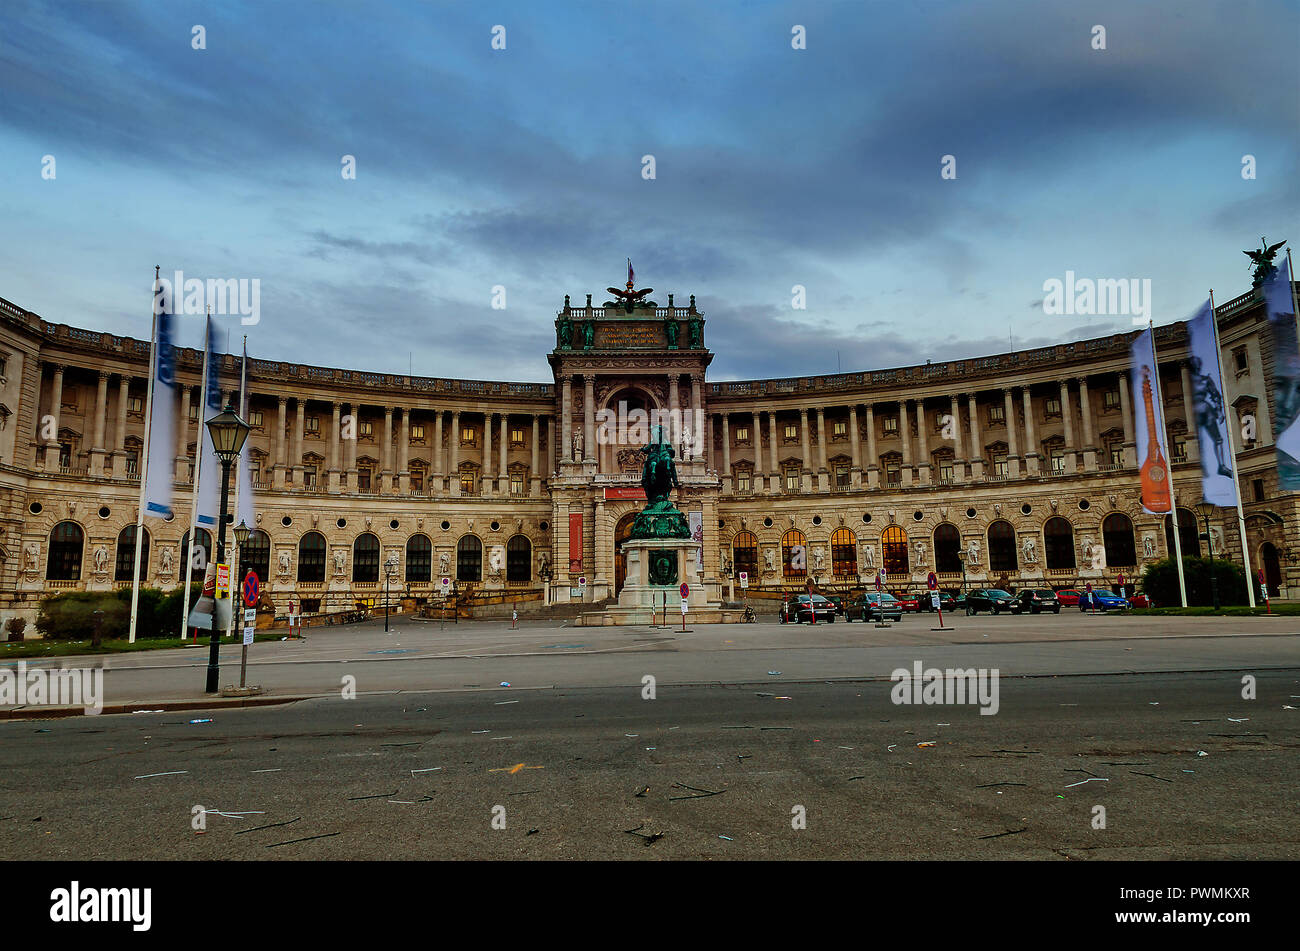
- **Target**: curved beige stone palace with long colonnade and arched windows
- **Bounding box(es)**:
[0,275,1300,618]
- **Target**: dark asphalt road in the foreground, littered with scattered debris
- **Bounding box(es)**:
[0,670,1300,860]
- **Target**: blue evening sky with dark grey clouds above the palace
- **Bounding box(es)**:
[0,0,1300,381]
